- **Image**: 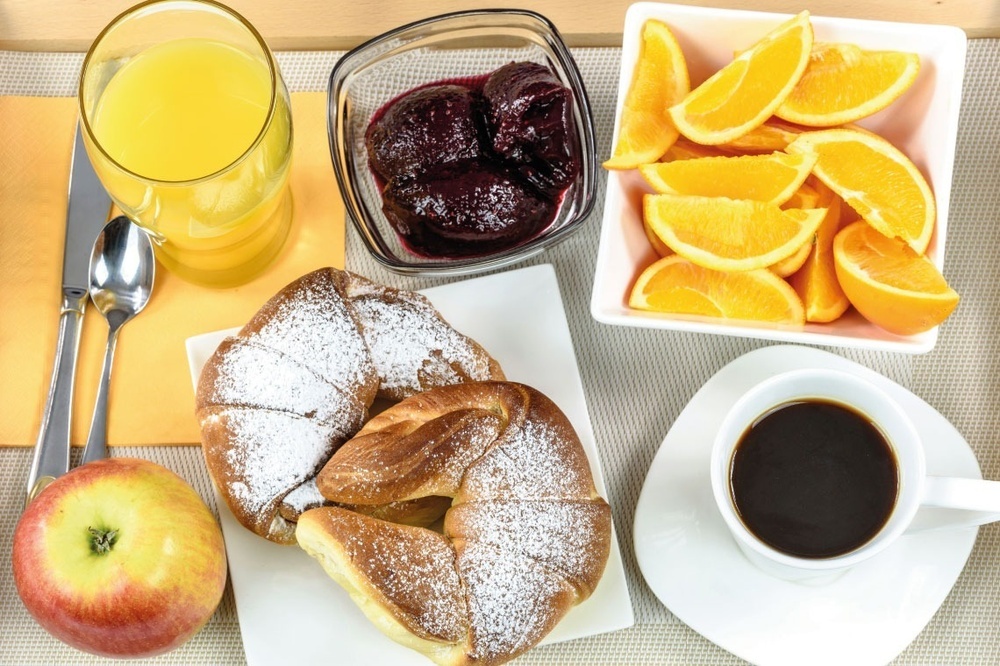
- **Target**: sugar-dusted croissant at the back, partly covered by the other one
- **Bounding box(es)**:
[196,268,503,544]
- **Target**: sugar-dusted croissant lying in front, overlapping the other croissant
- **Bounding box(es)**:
[296,382,611,664]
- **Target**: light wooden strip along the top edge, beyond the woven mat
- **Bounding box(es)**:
[0,0,1000,51]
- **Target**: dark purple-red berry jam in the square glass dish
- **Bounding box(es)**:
[365,62,581,258]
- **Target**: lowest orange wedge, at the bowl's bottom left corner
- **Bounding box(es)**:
[629,255,804,325]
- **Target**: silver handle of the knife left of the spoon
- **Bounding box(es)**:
[26,289,87,504]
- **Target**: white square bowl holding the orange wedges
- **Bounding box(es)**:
[591,2,966,354]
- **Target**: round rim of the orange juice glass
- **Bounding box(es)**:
[77,0,282,187]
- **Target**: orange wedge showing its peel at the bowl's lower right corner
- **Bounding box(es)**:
[833,221,958,335]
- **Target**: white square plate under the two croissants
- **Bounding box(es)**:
[187,265,634,666]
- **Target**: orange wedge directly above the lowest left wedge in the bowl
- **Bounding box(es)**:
[643,194,826,271]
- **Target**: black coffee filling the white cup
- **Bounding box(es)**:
[730,401,899,558]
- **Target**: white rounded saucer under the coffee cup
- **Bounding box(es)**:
[635,345,982,666]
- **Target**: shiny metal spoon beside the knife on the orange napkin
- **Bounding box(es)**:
[82,215,156,463]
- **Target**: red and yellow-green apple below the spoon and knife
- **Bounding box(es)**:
[12,458,226,657]
